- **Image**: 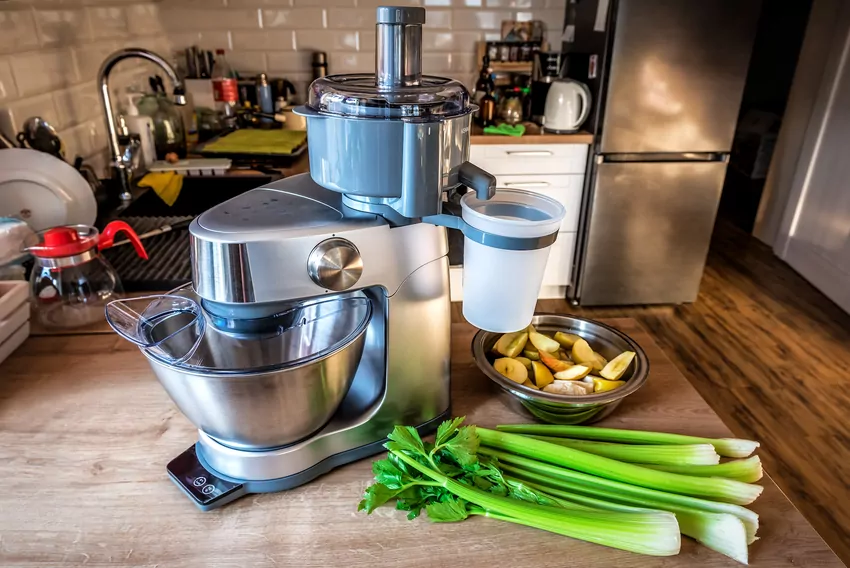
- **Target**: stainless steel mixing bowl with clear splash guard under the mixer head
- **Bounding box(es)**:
[107,289,372,449]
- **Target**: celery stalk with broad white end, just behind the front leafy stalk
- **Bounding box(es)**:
[506,474,748,564]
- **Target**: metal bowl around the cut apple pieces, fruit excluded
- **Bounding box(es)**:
[472,314,649,424]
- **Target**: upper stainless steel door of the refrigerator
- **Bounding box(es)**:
[600,0,760,153]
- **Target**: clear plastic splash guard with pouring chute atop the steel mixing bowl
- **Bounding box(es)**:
[106,287,372,375]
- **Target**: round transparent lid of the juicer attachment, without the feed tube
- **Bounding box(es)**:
[307,73,474,119]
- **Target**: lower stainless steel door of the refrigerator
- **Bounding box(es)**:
[578,162,726,305]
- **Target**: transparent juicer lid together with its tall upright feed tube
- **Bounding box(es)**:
[307,6,475,121]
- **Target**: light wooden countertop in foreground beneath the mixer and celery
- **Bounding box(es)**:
[0,319,841,568]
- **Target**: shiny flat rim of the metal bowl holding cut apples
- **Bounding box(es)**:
[472,312,649,406]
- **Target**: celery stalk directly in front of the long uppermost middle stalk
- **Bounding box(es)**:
[479,448,759,544]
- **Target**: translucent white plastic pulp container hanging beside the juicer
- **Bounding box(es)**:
[460,189,566,333]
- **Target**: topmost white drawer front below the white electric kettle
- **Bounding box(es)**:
[469,144,588,175]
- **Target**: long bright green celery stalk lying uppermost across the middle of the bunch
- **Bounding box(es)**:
[477,428,762,505]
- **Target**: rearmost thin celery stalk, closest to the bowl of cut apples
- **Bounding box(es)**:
[496,424,759,458]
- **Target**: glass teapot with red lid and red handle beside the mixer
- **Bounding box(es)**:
[24,221,148,328]
